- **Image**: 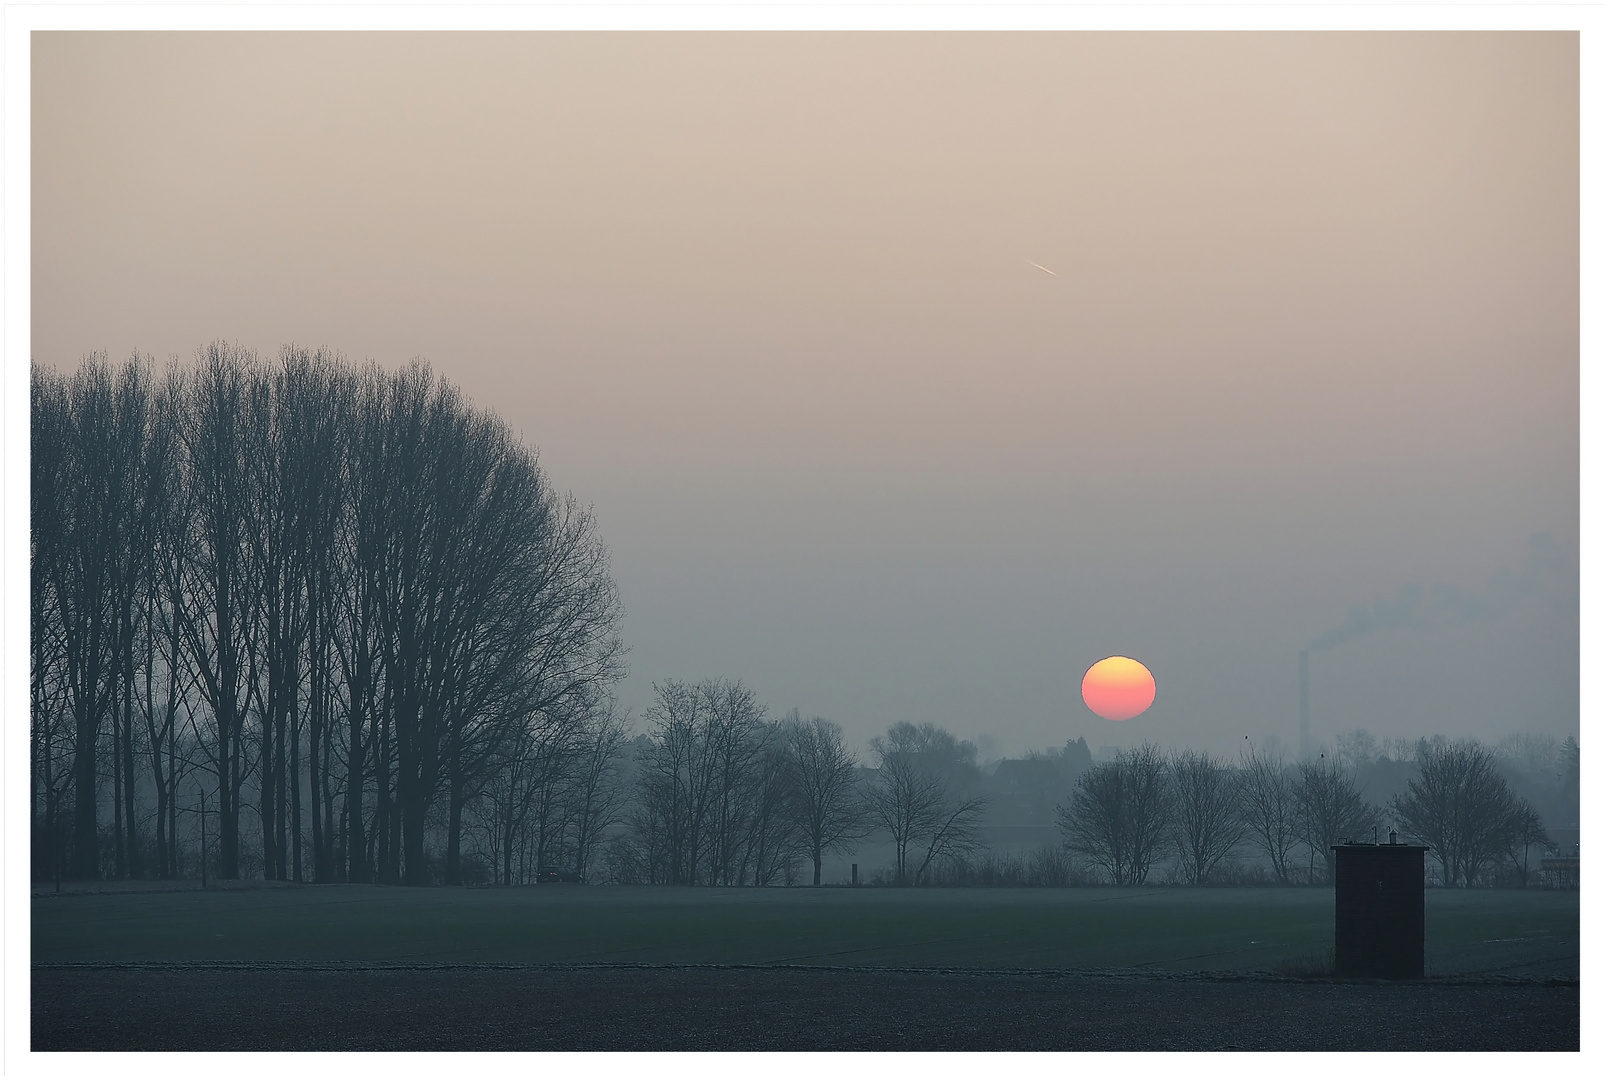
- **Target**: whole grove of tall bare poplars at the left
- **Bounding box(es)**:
[31,343,624,884]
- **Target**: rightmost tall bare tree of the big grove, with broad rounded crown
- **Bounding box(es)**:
[336,364,621,884]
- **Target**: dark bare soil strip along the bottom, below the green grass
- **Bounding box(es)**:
[32,966,1580,1051]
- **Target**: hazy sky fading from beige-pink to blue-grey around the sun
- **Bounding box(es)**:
[32,34,1580,755]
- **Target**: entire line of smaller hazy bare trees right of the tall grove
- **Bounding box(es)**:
[607,704,1578,887]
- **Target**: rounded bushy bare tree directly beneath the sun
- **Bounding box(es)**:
[1056,742,1173,885]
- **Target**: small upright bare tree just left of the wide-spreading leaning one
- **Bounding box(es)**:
[784,710,866,885]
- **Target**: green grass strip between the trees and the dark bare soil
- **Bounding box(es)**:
[32,885,1580,979]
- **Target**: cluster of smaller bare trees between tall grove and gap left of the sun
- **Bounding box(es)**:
[608,679,985,885]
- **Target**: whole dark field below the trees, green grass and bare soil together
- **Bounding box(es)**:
[32,885,1580,1051]
